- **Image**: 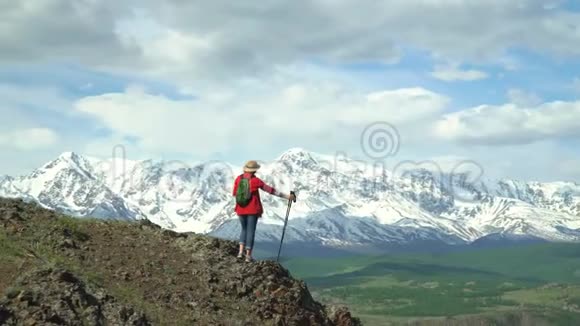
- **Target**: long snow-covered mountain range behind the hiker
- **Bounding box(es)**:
[0,148,580,245]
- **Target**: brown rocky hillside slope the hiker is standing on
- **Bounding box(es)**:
[0,199,360,326]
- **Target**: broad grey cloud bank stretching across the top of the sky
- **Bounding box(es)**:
[0,0,580,82]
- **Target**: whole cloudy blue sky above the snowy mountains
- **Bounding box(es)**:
[0,0,580,181]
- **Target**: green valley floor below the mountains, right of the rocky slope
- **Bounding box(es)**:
[285,243,580,325]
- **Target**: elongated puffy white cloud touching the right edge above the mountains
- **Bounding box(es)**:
[436,101,580,145]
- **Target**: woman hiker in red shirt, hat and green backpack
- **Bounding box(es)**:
[233,161,296,262]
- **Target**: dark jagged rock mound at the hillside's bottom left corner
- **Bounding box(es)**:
[0,268,151,326]
